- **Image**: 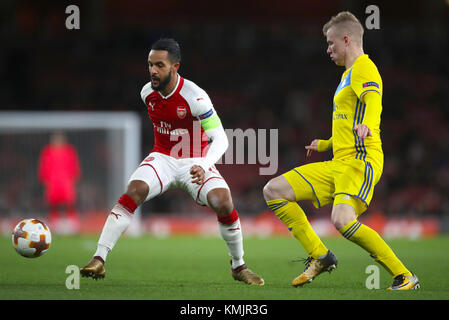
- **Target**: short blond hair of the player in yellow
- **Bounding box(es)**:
[323,11,364,45]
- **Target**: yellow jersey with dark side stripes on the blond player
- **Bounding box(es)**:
[319,54,383,170]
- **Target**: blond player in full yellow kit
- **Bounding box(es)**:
[263,11,419,290]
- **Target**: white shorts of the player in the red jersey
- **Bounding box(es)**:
[128,152,229,206]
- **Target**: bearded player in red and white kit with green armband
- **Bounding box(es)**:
[81,39,264,285]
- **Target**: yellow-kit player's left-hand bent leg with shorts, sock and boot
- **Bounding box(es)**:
[263,163,337,286]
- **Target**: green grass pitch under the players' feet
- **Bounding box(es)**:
[0,232,449,300]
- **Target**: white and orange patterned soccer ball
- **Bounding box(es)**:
[12,219,51,258]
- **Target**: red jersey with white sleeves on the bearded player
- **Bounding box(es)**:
[141,74,215,158]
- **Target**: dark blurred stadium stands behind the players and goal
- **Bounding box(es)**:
[0,0,449,235]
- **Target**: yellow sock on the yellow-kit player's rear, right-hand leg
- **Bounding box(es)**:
[338,220,412,278]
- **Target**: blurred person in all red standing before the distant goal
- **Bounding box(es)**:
[38,131,81,232]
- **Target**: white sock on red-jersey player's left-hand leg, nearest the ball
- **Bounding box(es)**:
[94,204,132,261]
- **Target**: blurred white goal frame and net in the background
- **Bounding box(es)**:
[0,111,141,235]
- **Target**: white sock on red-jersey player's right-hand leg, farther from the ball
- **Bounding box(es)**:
[218,219,245,269]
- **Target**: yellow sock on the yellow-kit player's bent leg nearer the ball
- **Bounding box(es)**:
[267,199,328,259]
